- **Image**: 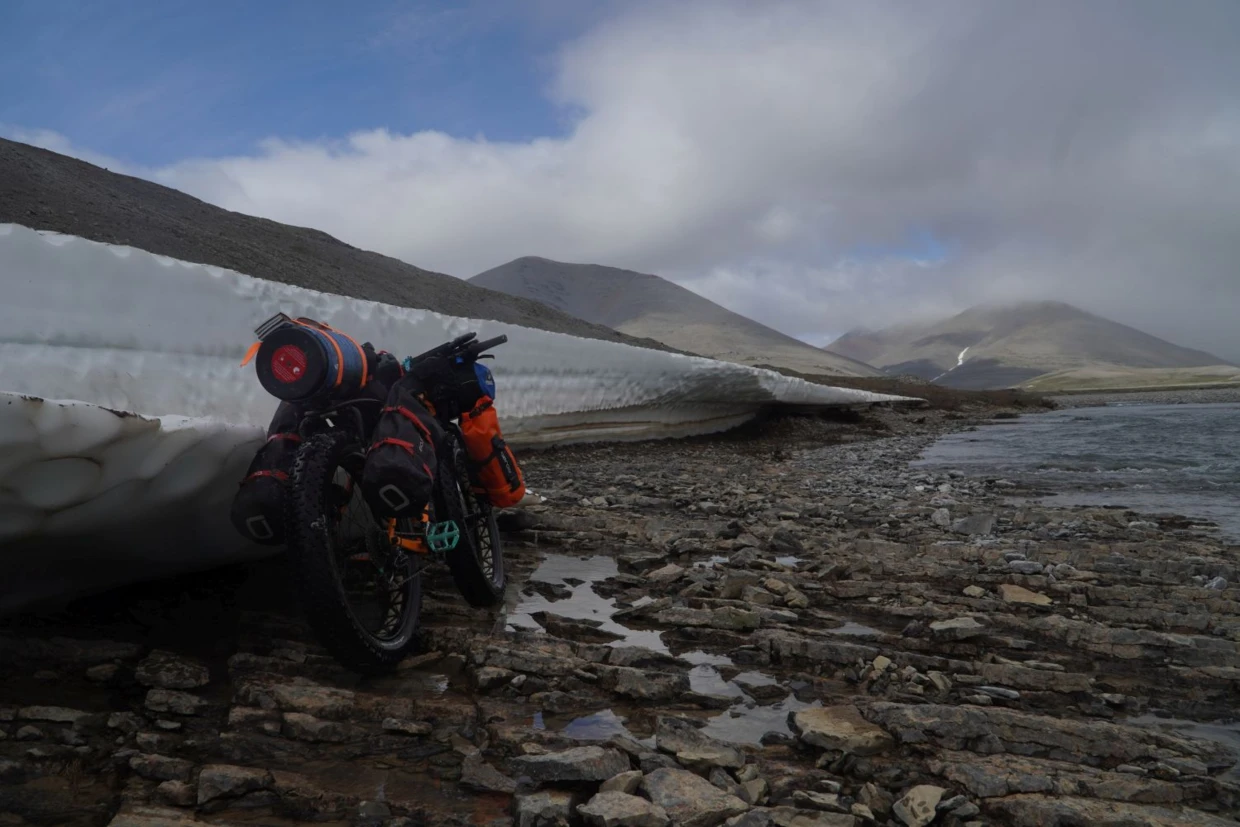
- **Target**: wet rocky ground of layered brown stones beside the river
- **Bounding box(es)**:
[0,410,1240,827]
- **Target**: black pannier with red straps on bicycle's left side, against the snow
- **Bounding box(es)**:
[228,402,301,546]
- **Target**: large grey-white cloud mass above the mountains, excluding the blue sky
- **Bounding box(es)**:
[24,0,1240,360]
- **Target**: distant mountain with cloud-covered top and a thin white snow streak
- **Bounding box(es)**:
[826,301,1226,389]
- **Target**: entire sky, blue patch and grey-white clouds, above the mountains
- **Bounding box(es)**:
[0,0,1240,361]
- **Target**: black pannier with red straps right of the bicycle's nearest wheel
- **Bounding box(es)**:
[361,382,444,520]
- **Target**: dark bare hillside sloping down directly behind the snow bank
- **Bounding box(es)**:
[0,139,670,350]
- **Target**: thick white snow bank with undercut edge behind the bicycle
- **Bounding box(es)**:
[0,224,899,609]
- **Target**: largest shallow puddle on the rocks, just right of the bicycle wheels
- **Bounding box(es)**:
[505,554,670,653]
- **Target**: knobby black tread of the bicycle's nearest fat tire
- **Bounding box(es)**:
[286,433,422,674]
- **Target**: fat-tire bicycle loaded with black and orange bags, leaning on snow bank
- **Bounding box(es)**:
[232,314,525,673]
